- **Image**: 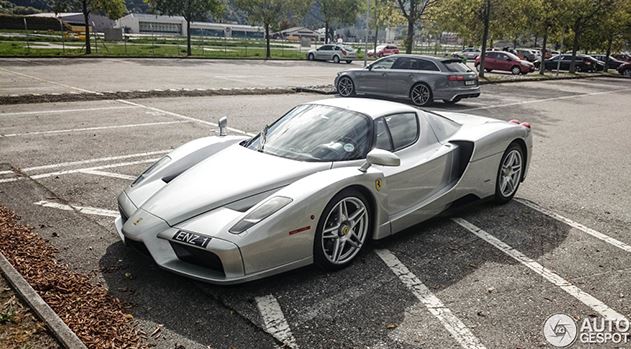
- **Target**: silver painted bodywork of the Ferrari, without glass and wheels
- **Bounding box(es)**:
[115,98,532,284]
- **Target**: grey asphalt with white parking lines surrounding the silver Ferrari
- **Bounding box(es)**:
[0,75,631,348]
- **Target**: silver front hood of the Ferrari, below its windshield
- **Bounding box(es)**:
[142,144,331,226]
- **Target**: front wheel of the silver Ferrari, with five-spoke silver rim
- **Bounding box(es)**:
[313,188,372,271]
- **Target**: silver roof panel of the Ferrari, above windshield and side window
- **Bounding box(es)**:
[305,98,418,119]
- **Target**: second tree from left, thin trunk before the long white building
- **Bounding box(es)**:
[146,0,223,56]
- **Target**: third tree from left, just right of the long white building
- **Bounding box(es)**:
[236,0,308,59]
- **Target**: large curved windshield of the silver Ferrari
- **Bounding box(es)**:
[244,104,372,161]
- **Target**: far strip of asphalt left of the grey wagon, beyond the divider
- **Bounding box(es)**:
[0,58,363,96]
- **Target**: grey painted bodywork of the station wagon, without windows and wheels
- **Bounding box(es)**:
[334,55,480,101]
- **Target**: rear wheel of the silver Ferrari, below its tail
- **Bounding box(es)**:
[495,143,526,204]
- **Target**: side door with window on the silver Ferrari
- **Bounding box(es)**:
[375,112,455,231]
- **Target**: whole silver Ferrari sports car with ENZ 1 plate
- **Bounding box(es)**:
[115,98,532,284]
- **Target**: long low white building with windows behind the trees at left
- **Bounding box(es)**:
[116,13,265,39]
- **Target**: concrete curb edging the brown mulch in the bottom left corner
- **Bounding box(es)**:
[0,252,87,349]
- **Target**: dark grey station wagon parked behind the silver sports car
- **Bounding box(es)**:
[335,55,480,106]
